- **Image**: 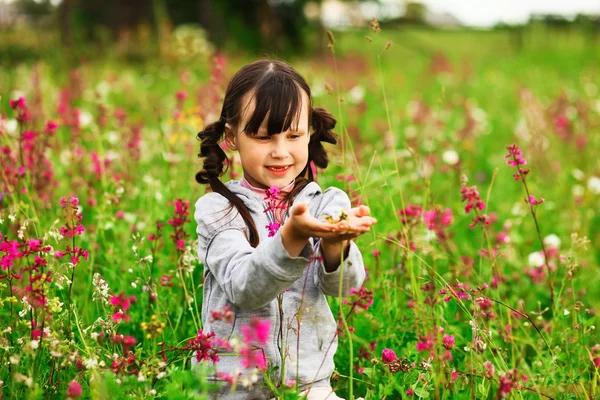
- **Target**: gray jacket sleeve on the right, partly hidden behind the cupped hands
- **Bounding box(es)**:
[314,187,366,297]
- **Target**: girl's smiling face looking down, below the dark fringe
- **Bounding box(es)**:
[225,91,310,189]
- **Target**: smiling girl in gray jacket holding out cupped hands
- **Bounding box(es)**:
[193,60,376,400]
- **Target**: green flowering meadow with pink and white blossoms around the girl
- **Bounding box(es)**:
[0,24,600,399]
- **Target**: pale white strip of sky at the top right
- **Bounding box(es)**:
[381,0,600,27]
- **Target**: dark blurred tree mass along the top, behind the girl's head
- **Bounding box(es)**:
[52,0,380,53]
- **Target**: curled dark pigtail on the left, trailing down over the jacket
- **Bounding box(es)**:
[196,117,259,247]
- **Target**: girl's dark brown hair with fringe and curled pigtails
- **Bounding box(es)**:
[196,60,337,247]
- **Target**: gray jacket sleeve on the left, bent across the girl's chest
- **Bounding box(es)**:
[194,194,314,310]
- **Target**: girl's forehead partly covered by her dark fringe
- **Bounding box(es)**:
[238,88,311,135]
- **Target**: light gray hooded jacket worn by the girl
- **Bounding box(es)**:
[193,181,365,398]
